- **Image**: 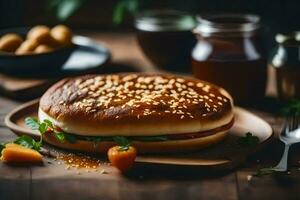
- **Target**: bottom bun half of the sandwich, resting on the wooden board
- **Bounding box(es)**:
[43,130,228,153]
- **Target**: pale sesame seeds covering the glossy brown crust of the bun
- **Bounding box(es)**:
[59,74,228,119]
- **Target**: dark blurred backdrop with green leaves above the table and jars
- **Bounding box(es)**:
[0,0,300,49]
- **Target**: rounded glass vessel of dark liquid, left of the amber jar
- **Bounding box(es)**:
[135,10,196,72]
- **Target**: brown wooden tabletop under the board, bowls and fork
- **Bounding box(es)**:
[0,33,300,200]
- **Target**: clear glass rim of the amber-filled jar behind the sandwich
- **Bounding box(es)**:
[194,14,260,37]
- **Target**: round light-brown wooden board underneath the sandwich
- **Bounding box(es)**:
[5,100,273,169]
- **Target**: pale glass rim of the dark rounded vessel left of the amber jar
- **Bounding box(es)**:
[135,10,196,31]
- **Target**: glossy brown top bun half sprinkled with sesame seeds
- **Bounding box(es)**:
[39,73,233,136]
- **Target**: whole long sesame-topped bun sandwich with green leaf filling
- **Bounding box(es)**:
[38,73,234,153]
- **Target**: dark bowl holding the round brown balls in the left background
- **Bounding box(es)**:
[0,28,77,76]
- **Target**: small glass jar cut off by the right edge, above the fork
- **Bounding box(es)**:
[270,33,300,100]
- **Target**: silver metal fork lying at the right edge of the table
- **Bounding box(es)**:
[272,116,300,172]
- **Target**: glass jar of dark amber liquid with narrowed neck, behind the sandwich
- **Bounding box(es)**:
[192,14,267,103]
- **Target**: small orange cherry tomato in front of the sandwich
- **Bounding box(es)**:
[107,146,136,172]
